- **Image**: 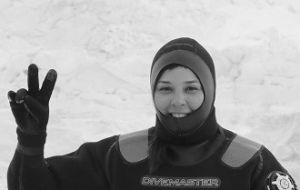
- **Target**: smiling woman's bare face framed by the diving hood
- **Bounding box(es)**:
[154,66,204,117]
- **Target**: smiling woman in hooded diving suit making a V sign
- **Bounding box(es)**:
[8,38,297,190]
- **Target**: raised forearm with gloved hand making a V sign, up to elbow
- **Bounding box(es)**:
[7,64,58,190]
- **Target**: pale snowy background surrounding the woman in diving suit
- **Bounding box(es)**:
[0,0,300,189]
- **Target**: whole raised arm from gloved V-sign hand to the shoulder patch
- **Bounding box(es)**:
[7,64,112,190]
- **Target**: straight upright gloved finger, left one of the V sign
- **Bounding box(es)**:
[27,64,39,95]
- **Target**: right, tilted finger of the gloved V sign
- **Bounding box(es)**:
[40,69,57,105]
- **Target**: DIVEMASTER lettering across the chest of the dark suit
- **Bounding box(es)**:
[141,176,221,188]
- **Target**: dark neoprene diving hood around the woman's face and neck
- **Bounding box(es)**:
[150,38,218,144]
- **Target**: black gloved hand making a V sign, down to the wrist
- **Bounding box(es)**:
[8,64,57,147]
